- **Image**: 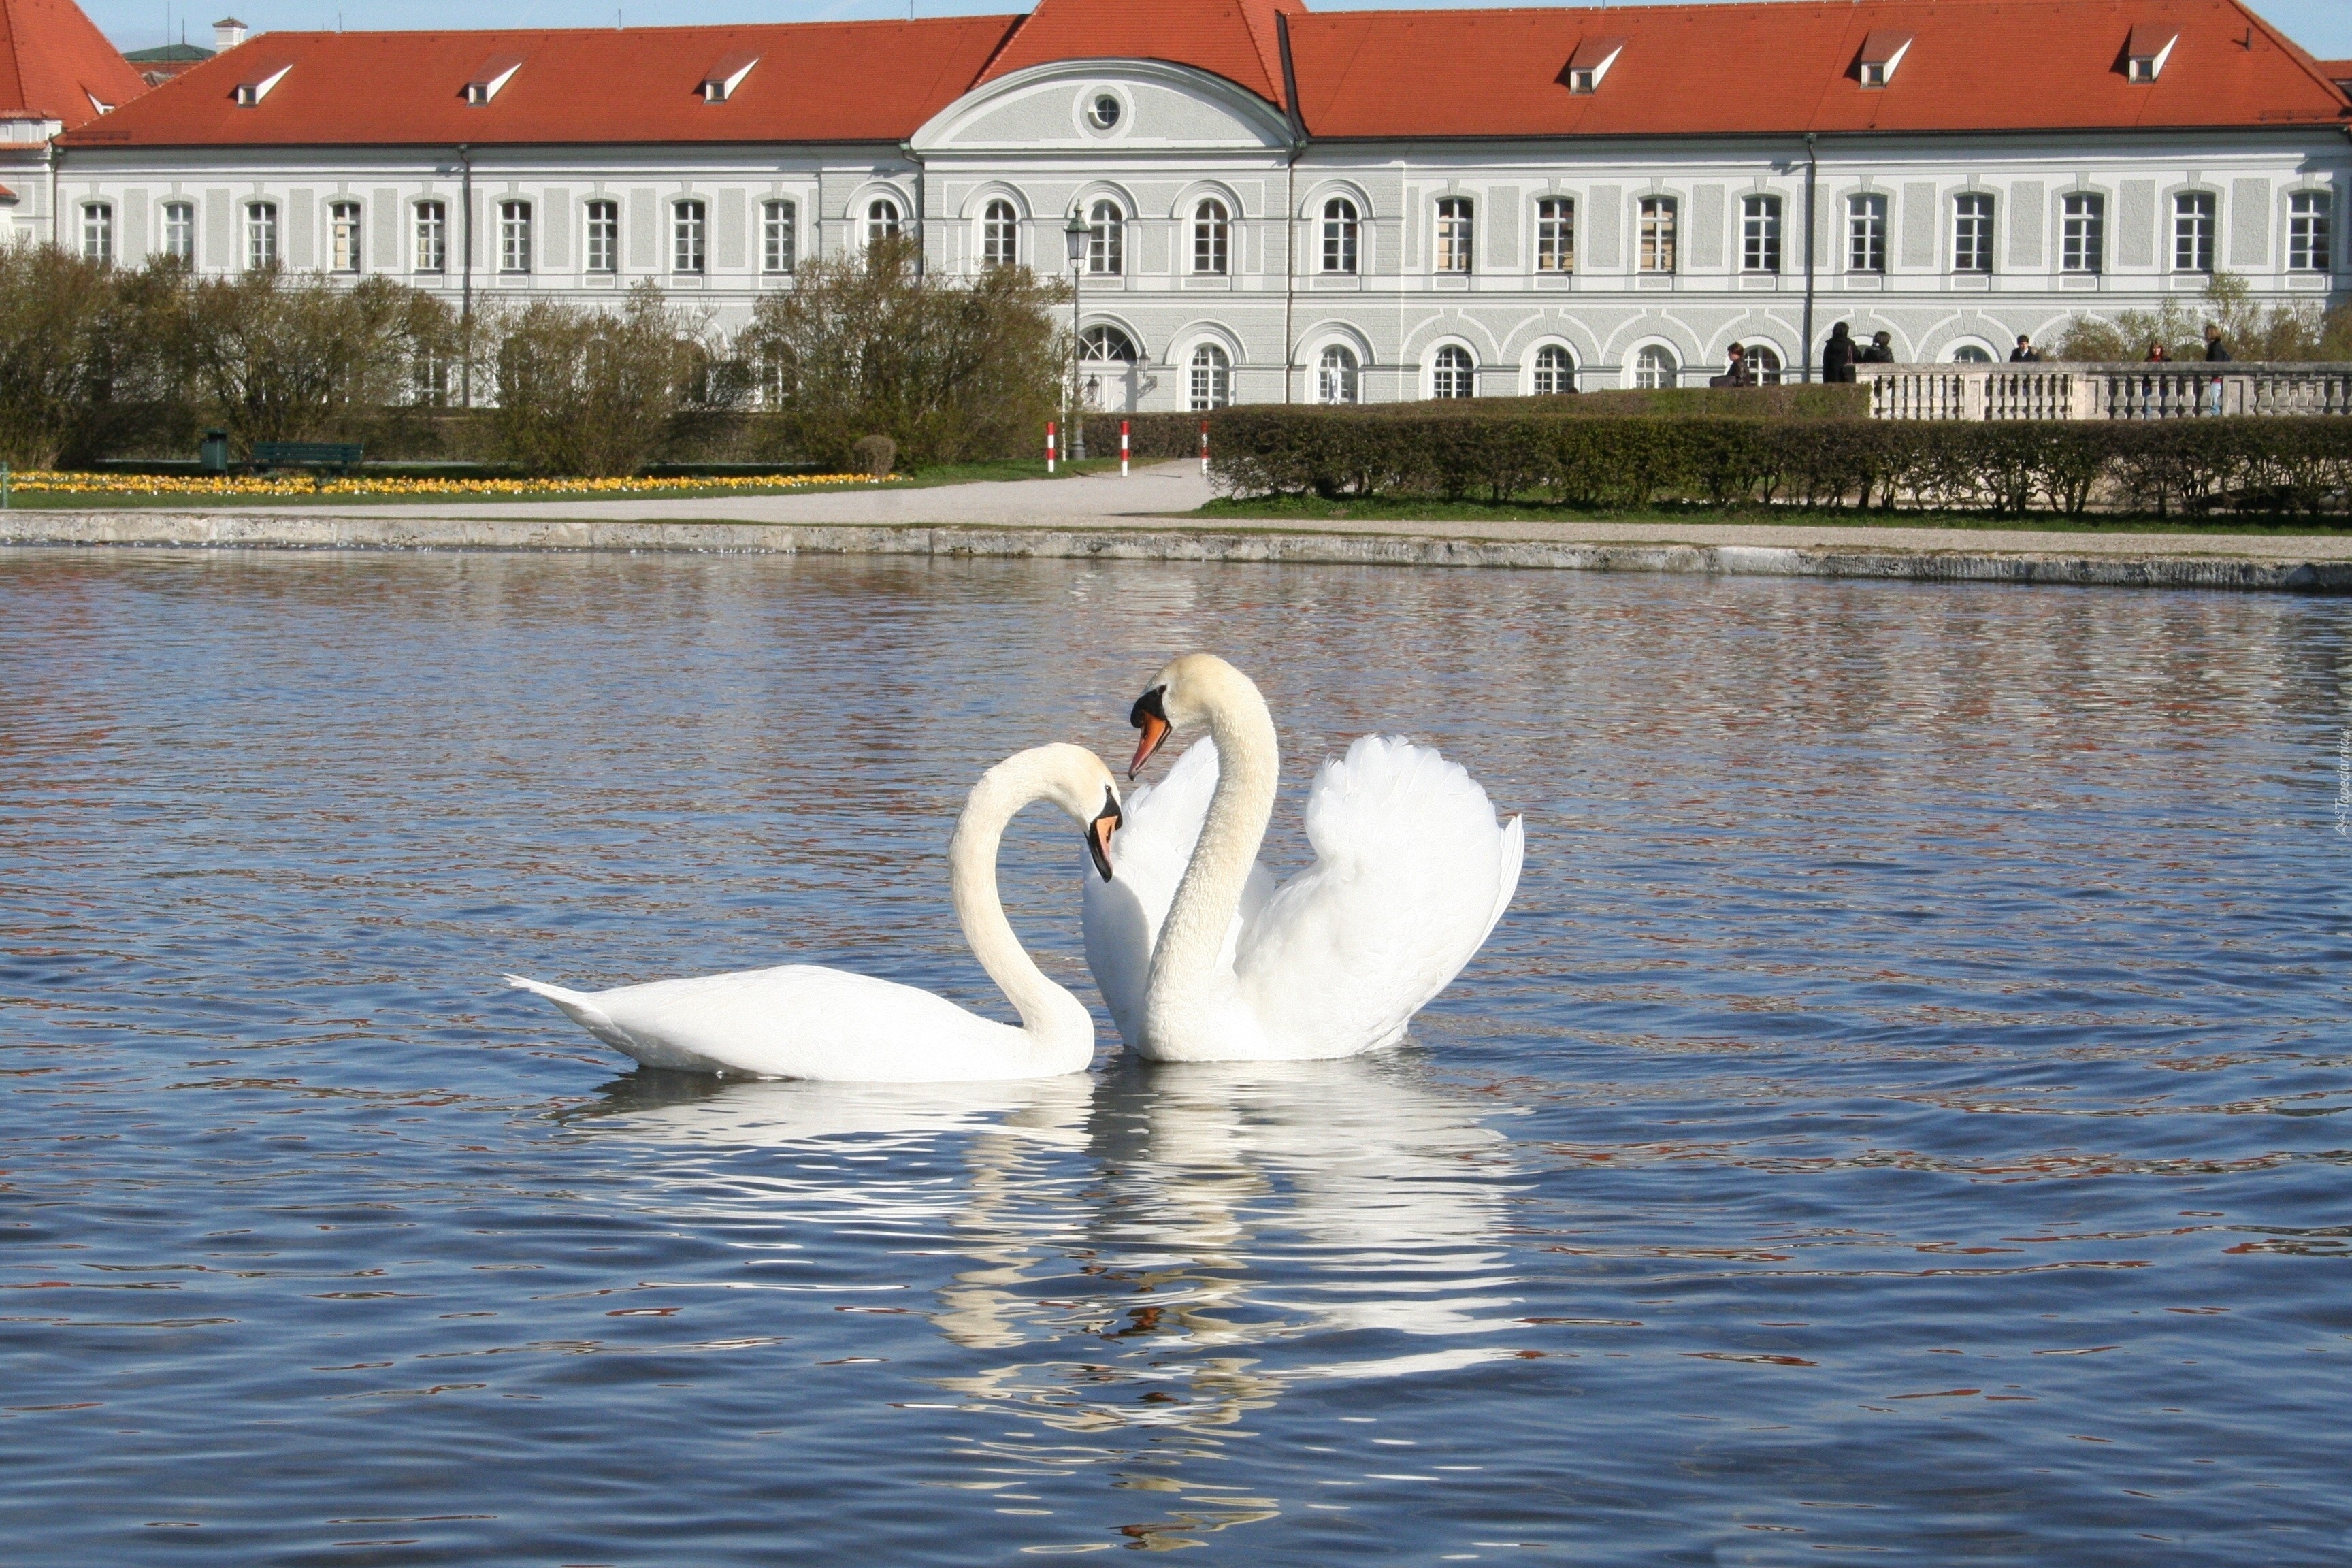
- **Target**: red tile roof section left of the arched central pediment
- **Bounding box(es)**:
[73,16,1018,146]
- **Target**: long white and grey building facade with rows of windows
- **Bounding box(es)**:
[45,0,2352,411]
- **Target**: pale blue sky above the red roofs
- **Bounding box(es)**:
[82,0,2352,59]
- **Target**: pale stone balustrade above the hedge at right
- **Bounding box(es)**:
[1853,364,2352,419]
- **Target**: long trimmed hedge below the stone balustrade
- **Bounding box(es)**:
[1211,404,2352,517]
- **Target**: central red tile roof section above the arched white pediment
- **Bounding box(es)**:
[981,0,1308,103]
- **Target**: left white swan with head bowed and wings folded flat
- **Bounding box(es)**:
[506,745,1120,1083]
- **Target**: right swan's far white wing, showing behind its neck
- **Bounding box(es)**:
[1082,738,1275,1044]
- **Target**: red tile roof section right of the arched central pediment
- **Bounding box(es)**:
[1291,0,2347,139]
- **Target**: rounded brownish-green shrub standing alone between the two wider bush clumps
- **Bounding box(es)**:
[496,282,719,477]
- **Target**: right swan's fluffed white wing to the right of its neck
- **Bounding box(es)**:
[1237,736,1524,1056]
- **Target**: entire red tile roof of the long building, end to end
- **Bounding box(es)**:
[50,0,2352,146]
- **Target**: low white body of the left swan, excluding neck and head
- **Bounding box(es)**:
[508,964,1077,1083]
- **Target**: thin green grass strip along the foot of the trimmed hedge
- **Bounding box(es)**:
[1190,496,2352,536]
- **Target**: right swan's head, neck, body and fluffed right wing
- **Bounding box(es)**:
[1129,653,1524,1060]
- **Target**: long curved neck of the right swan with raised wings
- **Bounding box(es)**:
[1143,670,1282,1039]
